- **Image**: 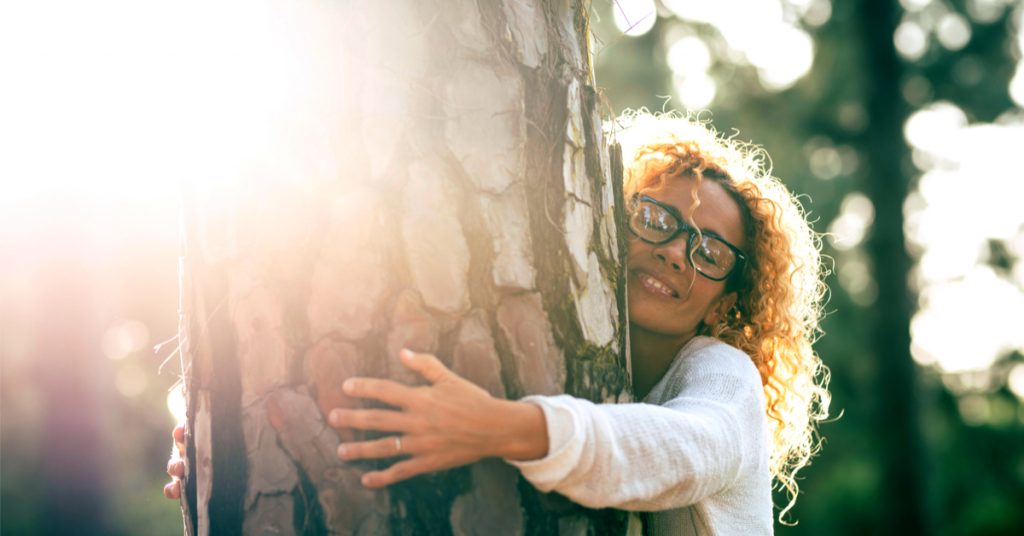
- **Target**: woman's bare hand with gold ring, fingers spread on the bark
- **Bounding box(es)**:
[329,349,548,488]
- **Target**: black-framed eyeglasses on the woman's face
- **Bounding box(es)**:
[630,194,746,281]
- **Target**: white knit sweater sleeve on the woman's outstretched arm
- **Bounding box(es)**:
[511,351,765,511]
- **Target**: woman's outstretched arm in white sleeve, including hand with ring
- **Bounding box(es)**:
[331,353,767,510]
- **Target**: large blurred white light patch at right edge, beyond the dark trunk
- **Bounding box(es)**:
[904,102,1024,372]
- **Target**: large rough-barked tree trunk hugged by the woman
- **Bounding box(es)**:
[179,0,629,535]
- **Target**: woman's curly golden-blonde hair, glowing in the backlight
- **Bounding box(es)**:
[615,111,830,521]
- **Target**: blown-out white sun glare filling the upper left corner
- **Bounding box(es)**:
[0,0,348,216]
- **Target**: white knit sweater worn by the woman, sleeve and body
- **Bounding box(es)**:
[511,337,773,535]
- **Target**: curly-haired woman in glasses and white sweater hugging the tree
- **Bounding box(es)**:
[167,113,829,534]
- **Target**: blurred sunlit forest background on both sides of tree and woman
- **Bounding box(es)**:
[6,0,1024,535]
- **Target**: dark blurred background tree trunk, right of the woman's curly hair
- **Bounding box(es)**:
[860,0,931,534]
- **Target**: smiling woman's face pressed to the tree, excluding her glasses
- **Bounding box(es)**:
[628,177,745,342]
